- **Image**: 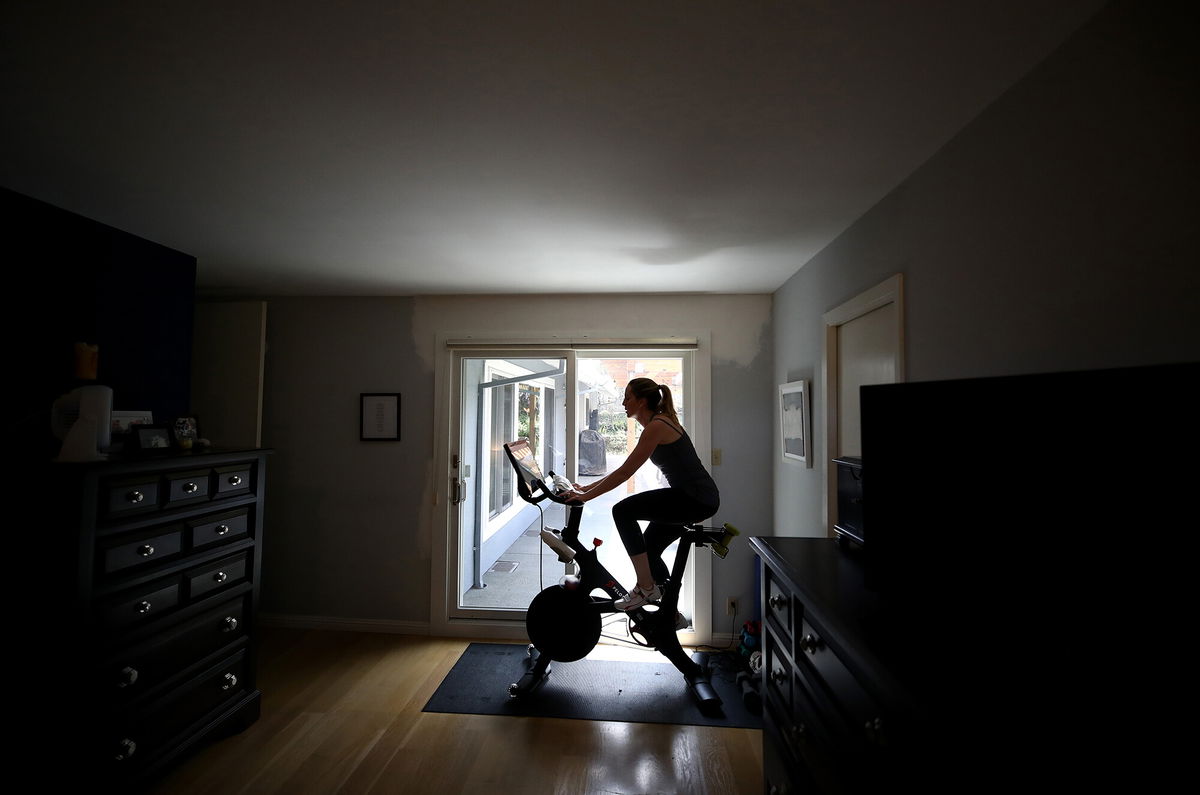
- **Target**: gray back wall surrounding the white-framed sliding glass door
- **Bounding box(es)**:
[263,295,772,633]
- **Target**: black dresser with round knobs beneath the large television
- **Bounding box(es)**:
[750,528,1196,795]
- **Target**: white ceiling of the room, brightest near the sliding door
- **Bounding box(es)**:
[0,0,1102,295]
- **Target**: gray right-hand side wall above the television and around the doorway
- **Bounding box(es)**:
[774,2,1200,536]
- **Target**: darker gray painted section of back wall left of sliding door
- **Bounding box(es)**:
[262,298,433,624]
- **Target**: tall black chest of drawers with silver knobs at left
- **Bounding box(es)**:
[34,450,268,785]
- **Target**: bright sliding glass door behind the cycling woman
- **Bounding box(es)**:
[448,348,694,634]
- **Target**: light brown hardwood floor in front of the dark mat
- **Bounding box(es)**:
[140,628,762,795]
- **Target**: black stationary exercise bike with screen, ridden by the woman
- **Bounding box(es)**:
[504,440,739,713]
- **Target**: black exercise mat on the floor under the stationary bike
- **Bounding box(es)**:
[422,644,762,729]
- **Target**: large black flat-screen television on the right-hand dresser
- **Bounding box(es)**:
[860,363,1200,595]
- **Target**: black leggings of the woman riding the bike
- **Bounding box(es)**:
[612,489,720,582]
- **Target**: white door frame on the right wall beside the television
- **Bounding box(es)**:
[821,274,905,537]
